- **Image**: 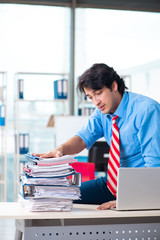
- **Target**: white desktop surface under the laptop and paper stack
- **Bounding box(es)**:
[0,202,160,219]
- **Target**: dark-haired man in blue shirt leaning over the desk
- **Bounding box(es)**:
[33,64,160,210]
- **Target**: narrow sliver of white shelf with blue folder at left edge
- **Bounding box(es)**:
[0,72,7,201]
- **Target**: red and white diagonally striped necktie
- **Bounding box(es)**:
[107,116,120,197]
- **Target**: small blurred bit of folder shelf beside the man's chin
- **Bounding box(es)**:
[78,93,95,116]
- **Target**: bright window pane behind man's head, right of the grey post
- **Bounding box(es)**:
[76,9,160,107]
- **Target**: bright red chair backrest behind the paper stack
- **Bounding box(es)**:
[70,162,95,182]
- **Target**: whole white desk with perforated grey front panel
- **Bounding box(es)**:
[0,203,160,240]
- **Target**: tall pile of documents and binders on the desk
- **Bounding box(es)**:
[18,154,81,211]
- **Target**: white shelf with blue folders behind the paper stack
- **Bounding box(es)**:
[14,72,70,201]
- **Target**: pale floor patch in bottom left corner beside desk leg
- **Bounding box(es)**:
[0,219,15,240]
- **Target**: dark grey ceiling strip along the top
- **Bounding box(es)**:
[0,0,160,12]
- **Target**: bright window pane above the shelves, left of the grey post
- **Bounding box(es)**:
[0,4,70,122]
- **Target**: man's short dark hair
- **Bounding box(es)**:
[77,63,127,95]
